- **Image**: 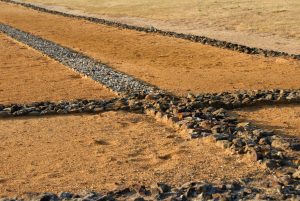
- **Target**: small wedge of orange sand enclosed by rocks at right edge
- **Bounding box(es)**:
[236,105,300,138]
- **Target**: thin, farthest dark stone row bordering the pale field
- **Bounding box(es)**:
[0,0,300,60]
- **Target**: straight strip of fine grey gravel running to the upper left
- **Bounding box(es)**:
[0,23,160,94]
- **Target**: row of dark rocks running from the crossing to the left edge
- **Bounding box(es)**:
[0,98,143,118]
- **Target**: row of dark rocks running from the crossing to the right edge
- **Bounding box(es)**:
[182,89,300,110]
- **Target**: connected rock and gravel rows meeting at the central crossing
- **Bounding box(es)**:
[0,7,300,200]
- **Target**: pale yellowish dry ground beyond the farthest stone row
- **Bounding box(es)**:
[20,0,300,54]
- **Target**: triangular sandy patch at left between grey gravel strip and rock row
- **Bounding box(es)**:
[0,34,115,104]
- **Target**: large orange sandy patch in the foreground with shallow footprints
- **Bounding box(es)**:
[0,112,263,197]
